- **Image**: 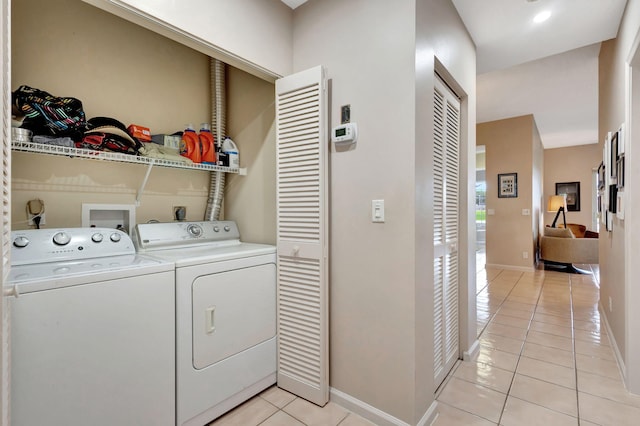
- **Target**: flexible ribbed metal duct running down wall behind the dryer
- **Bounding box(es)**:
[204,58,227,220]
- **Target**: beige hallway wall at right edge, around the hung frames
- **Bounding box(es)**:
[598,0,640,393]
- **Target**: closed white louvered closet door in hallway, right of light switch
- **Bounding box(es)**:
[433,77,460,388]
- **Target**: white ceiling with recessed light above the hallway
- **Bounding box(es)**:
[282,0,627,149]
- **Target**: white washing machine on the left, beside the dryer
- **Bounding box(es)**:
[5,228,175,426]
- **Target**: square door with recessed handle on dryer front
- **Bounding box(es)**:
[192,264,276,370]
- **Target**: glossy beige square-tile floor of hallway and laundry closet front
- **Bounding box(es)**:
[210,265,640,426]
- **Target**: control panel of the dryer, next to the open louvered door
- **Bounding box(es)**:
[133,220,240,251]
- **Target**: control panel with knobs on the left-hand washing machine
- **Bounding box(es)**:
[11,228,135,265]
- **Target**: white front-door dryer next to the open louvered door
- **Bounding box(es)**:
[134,221,276,426]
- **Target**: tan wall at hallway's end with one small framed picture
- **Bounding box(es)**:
[477,115,540,270]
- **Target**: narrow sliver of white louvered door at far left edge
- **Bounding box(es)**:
[0,0,11,426]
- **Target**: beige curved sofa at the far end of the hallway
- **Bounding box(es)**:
[540,225,599,264]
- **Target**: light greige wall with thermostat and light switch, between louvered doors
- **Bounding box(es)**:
[294,0,475,424]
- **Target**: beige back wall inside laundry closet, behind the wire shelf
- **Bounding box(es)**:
[12,0,275,242]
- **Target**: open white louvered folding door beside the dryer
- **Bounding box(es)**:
[276,67,329,406]
